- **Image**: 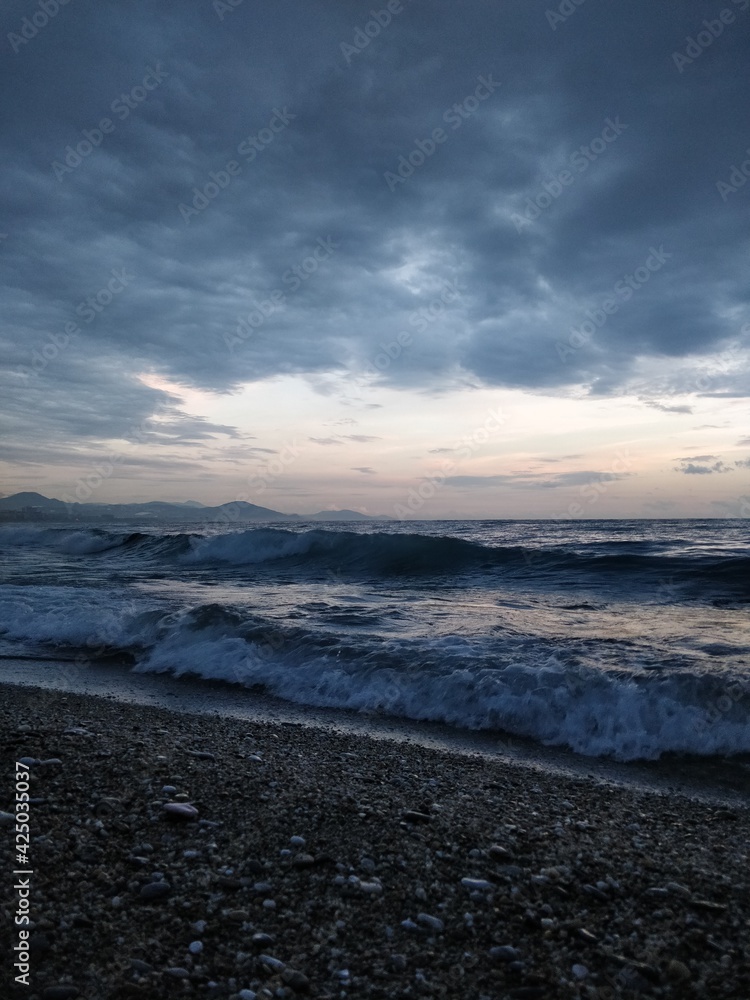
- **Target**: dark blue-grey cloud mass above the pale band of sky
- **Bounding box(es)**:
[0,0,750,460]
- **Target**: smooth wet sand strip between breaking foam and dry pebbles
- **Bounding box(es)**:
[0,655,750,807]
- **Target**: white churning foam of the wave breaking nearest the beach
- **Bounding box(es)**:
[136,630,750,760]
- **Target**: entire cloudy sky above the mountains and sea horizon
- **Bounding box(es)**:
[0,0,750,518]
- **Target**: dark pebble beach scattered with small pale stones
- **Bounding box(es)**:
[0,685,750,1000]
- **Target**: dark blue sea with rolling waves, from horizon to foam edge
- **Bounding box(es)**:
[0,520,750,760]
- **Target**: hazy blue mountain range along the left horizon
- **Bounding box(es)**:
[0,492,394,524]
